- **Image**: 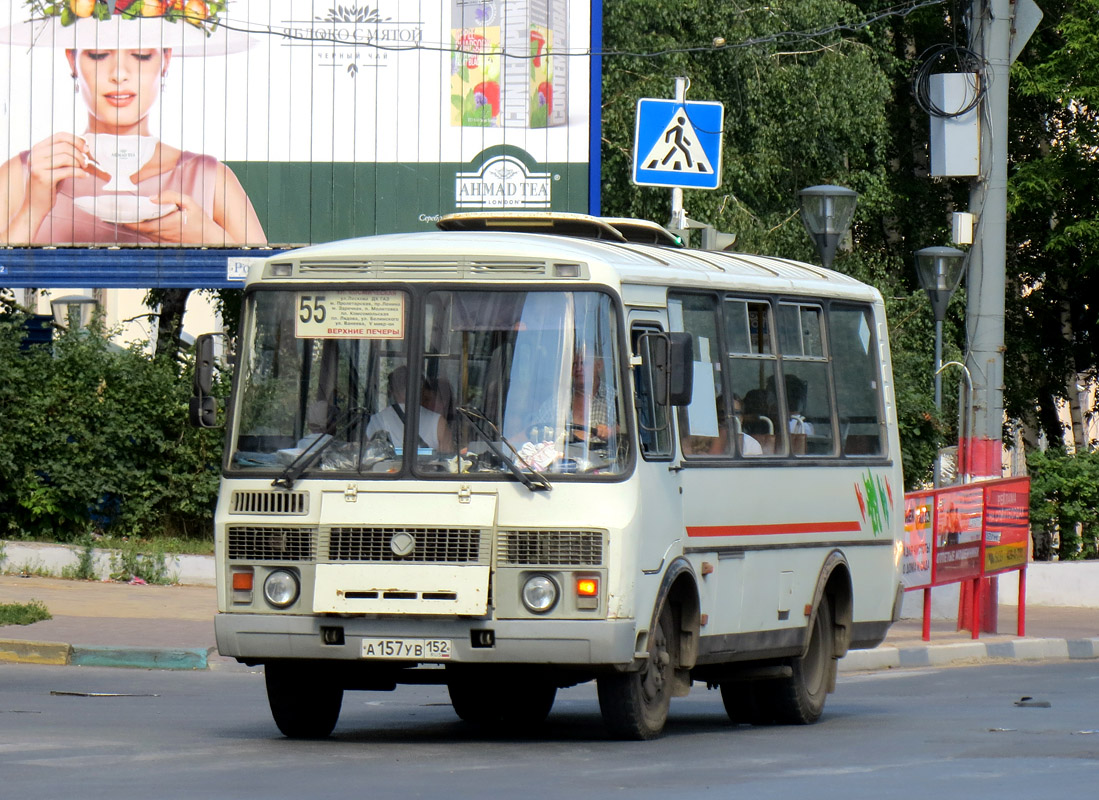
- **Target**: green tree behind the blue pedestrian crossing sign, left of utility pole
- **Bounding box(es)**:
[601,0,958,486]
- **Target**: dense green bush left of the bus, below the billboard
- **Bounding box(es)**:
[0,318,221,542]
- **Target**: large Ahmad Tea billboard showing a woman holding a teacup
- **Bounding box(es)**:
[0,0,600,287]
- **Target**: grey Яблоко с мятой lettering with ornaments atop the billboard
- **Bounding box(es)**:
[281,2,423,77]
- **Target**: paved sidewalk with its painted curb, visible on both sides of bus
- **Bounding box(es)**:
[0,575,1099,671]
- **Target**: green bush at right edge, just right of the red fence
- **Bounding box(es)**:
[1026,449,1099,560]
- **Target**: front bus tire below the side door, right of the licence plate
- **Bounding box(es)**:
[596,604,678,741]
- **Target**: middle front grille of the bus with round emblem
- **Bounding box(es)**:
[328,526,491,564]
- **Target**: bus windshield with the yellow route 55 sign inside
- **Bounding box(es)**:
[229,287,630,482]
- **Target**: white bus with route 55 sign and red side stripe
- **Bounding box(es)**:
[192,213,903,738]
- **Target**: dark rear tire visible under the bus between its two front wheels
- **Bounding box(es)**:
[446,670,557,732]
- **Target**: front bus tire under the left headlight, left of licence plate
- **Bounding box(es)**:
[264,662,343,738]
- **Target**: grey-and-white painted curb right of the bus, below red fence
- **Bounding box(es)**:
[839,637,1099,673]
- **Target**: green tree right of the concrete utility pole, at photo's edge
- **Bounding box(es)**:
[1004,0,1099,451]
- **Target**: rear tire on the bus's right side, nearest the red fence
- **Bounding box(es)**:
[773,597,836,725]
